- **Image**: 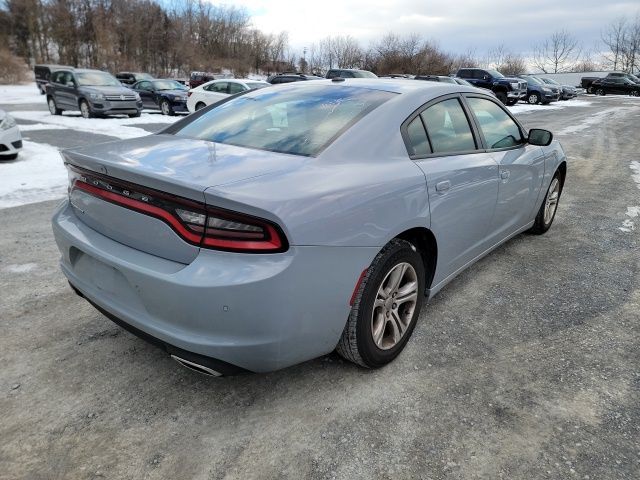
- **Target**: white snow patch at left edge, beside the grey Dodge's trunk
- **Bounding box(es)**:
[0,140,68,208]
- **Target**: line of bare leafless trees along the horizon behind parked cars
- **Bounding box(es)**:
[0,0,640,82]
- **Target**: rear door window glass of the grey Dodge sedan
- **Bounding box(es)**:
[421,98,476,153]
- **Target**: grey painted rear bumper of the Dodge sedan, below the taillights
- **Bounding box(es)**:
[53,201,377,373]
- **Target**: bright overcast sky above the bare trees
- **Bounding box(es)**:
[225,0,640,54]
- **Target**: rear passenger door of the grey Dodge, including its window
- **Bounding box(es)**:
[403,94,499,284]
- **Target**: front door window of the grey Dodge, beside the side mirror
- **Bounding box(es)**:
[467,98,524,149]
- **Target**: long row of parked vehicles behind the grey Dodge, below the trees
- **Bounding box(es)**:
[34,65,640,122]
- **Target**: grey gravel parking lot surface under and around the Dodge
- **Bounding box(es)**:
[0,92,640,480]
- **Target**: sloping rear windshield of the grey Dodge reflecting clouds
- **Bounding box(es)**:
[175,85,396,156]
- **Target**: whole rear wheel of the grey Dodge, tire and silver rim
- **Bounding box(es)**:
[336,239,425,368]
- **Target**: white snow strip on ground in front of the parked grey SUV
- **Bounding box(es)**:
[11,110,180,139]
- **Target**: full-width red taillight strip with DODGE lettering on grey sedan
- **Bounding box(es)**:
[67,165,288,253]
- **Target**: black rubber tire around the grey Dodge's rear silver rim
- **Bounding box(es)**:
[336,239,425,368]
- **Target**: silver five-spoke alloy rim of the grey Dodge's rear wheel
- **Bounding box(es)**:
[371,262,418,350]
